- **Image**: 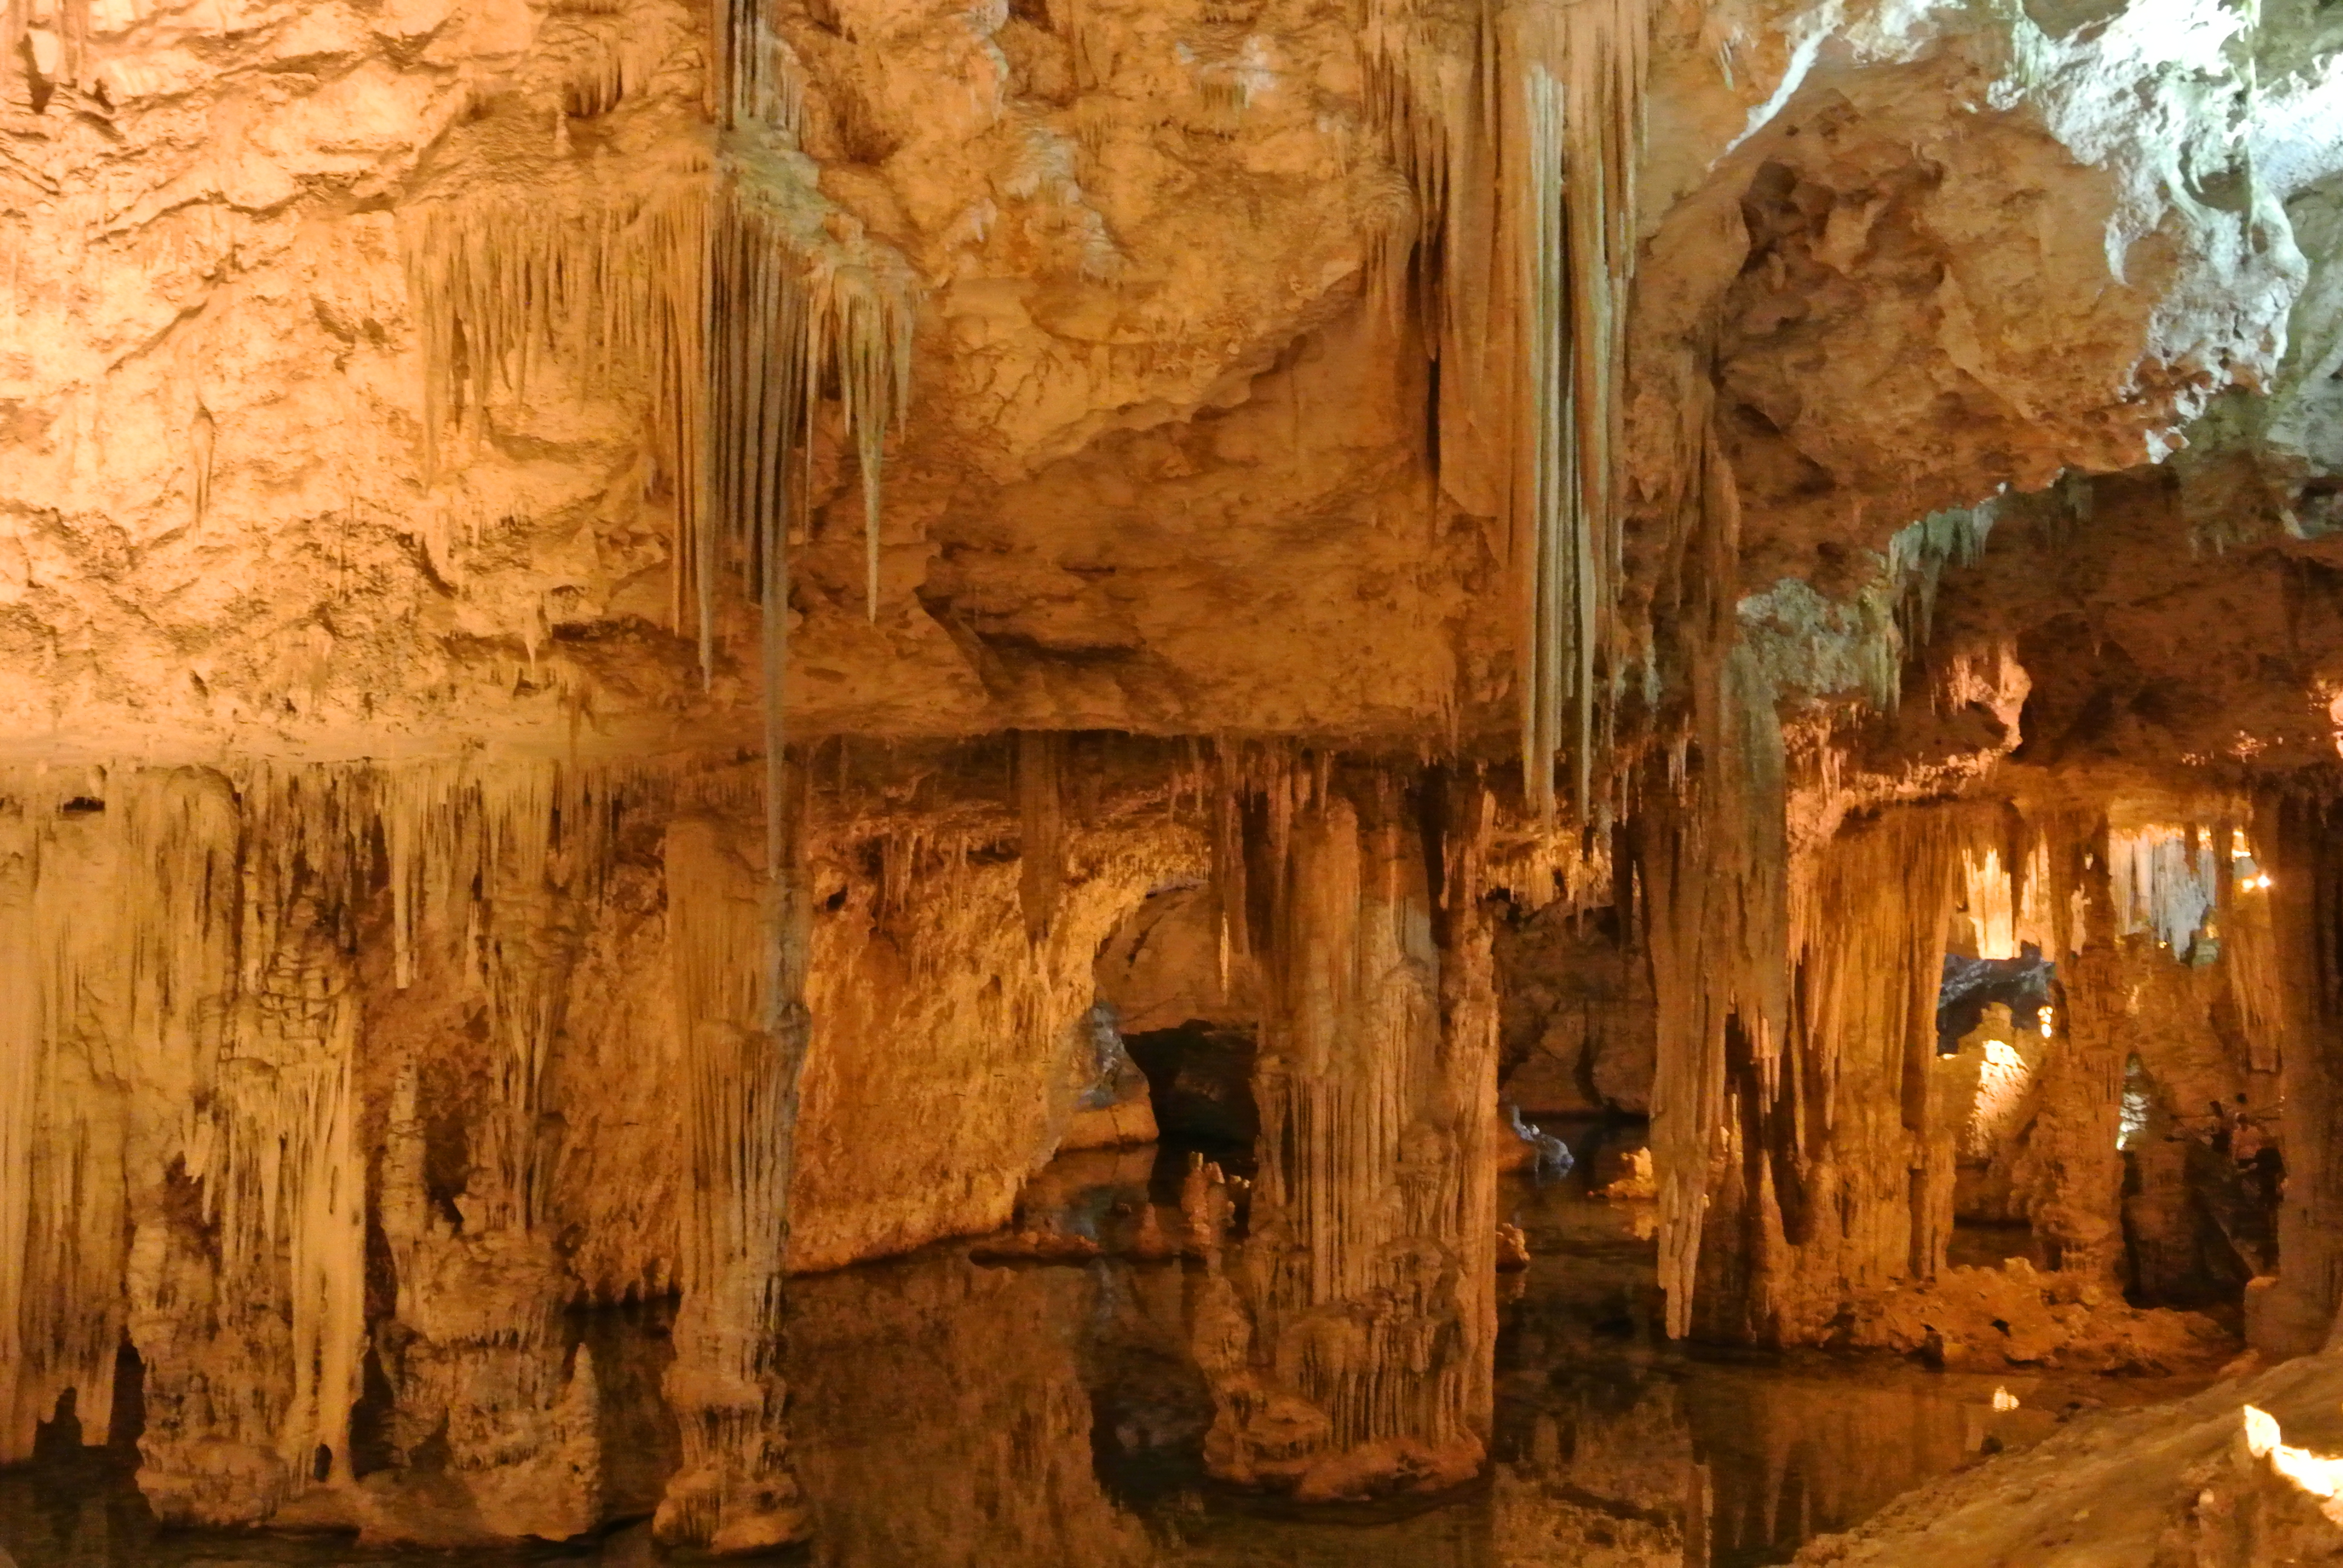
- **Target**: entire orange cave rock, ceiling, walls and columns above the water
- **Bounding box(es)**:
[13,0,2343,1561]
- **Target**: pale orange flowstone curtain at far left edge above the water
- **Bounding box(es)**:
[0,769,237,1463]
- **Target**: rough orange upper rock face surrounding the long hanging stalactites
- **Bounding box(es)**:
[0,5,2334,753]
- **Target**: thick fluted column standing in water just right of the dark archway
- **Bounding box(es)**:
[1198,774,1495,1498]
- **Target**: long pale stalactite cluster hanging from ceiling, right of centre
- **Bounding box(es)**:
[1362,0,1650,815]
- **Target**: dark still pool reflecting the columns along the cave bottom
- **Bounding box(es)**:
[0,1151,2205,1568]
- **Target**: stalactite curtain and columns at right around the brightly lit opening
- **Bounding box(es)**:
[1626,727,2336,1343]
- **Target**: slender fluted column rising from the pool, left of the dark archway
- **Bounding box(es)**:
[656,818,806,1552]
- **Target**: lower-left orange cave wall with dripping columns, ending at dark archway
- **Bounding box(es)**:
[0,736,1283,1547]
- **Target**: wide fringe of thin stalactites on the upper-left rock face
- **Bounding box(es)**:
[403,67,919,673]
